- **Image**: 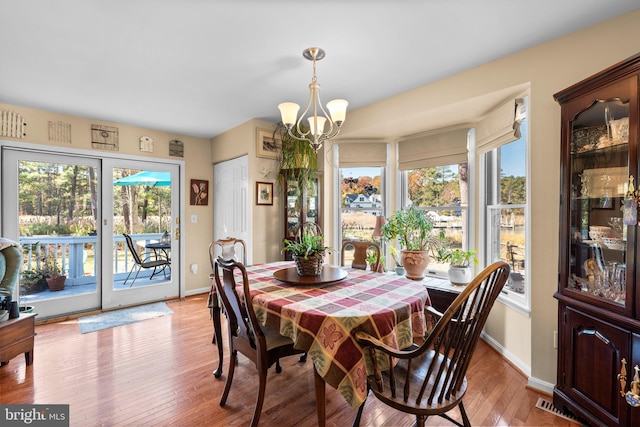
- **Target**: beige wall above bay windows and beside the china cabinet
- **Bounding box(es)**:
[325,10,640,386]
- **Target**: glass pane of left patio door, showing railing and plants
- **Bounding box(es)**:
[18,160,98,312]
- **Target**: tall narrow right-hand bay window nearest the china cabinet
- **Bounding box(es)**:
[480,100,529,310]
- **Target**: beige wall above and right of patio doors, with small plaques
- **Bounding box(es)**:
[0,104,213,294]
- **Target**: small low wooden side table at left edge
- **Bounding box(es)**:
[0,313,37,366]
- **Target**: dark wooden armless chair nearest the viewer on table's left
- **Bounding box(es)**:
[213,257,303,427]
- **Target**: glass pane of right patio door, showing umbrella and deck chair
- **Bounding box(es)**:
[113,168,172,289]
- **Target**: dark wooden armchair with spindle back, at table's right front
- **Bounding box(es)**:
[353,261,510,427]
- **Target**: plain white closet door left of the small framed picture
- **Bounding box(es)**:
[213,156,252,265]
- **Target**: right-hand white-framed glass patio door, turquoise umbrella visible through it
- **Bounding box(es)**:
[100,159,181,309]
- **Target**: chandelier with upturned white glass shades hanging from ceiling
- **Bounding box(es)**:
[278,47,349,153]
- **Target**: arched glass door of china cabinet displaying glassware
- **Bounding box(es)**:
[566,98,637,307]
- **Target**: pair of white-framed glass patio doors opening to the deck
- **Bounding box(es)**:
[2,147,180,319]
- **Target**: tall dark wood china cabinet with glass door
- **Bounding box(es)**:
[553,54,640,426]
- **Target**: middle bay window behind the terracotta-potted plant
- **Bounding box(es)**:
[406,163,469,275]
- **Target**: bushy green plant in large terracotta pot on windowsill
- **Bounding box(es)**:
[380,206,444,280]
